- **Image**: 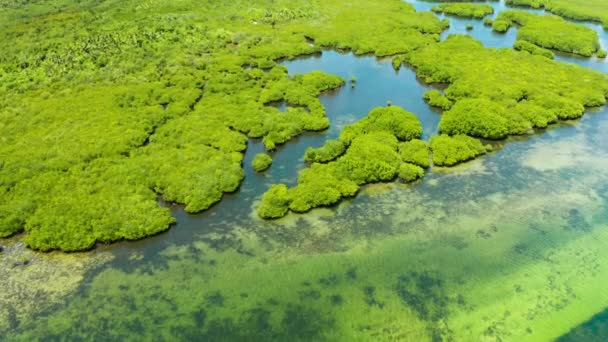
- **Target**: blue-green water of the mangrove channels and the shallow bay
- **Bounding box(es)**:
[0,3,608,341]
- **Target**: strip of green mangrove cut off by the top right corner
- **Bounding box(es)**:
[506,0,608,28]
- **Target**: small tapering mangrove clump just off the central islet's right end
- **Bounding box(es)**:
[430,134,491,166]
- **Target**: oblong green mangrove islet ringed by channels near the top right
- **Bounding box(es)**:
[493,11,600,56]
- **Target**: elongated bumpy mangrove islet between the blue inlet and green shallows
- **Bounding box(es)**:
[258,106,422,219]
